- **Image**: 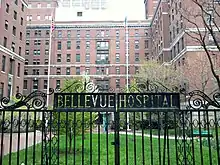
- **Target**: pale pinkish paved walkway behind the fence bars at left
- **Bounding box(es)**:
[0,131,42,155]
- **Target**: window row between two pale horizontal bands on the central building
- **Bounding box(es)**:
[24,67,139,75]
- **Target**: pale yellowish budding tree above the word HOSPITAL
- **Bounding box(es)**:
[135,60,180,91]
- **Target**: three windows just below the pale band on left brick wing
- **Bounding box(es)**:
[1,55,21,77]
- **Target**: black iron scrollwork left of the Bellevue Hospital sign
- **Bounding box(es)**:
[0,88,54,110]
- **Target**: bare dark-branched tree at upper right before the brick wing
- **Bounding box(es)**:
[180,0,220,91]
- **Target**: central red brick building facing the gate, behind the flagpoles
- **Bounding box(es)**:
[24,0,150,99]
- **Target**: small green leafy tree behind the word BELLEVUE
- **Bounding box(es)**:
[54,78,97,152]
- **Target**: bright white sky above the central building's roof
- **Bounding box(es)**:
[56,0,145,21]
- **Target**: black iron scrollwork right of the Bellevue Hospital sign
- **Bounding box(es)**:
[188,90,220,109]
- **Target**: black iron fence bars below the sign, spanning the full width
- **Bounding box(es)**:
[0,109,220,165]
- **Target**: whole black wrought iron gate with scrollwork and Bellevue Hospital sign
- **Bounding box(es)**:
[0,81,220,165]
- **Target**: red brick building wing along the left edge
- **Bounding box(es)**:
[0,0,27,98]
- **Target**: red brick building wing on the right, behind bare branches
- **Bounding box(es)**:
[145,0,220,93]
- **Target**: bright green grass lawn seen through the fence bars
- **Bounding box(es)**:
[3,134,218,165]
